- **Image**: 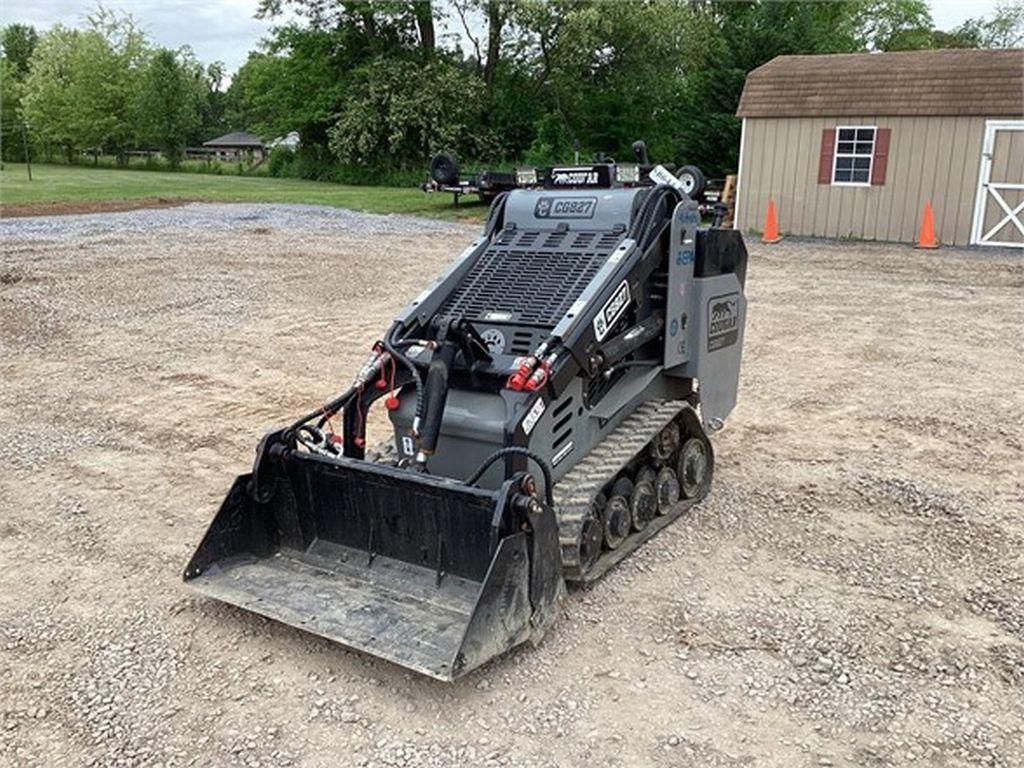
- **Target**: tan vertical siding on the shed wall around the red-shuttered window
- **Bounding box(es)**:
[738,116,991,245]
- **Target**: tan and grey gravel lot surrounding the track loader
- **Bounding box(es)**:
[0,205,1024,768]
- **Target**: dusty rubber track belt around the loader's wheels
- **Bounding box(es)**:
[555,400,692,582]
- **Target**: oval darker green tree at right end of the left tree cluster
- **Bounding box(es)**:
[135,48,203,167]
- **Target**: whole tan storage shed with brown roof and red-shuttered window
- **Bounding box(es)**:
[735,50,1024,248]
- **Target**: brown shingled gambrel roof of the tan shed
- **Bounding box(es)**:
[736,50,1024,118]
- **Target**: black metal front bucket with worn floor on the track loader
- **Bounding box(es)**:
[184,451,564,680]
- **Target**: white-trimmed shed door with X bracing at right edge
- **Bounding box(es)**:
[971,120,1024,248]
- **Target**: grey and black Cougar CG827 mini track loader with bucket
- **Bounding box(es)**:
[184,156,746,680]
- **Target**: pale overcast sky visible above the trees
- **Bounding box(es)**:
[0,0,996,72]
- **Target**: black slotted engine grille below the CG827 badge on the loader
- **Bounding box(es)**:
[440,228,624,328]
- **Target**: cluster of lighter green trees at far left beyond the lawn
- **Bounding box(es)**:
[0,7,227,166]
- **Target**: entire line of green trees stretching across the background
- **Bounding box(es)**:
[0,0,1024,182]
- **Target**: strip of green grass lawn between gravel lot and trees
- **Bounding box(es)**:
[0,163,487,219]
